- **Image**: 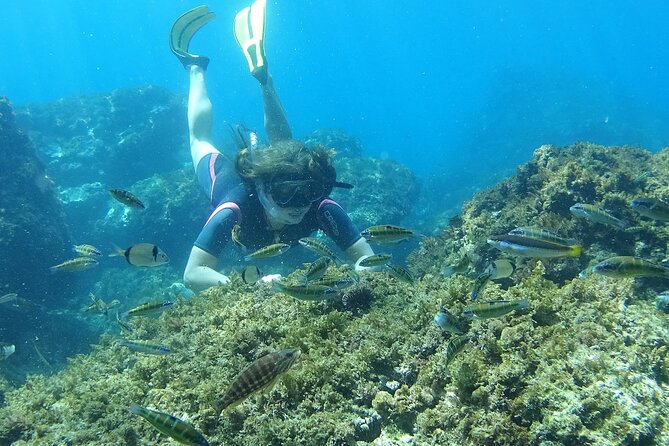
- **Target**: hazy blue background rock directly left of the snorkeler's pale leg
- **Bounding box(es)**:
[18,86,189,188]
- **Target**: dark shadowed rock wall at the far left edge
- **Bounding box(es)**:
[0,98,70,303]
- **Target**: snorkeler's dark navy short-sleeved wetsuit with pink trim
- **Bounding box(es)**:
[195,153,360,257]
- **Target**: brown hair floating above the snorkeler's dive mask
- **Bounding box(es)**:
[235,139,337,191]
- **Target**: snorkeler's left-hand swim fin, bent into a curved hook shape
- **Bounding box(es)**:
[170,5,216,69]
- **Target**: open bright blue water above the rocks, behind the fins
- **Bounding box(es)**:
[0,0,669,173]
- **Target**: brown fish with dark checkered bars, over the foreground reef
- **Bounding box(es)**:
[215,348,301,415]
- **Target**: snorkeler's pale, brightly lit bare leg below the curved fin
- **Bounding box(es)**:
[188,65,218,170]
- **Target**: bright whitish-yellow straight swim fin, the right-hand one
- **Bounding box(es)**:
[233,0,267,84]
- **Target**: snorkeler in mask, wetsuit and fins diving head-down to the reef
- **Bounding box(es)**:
[170,0,374,291]
